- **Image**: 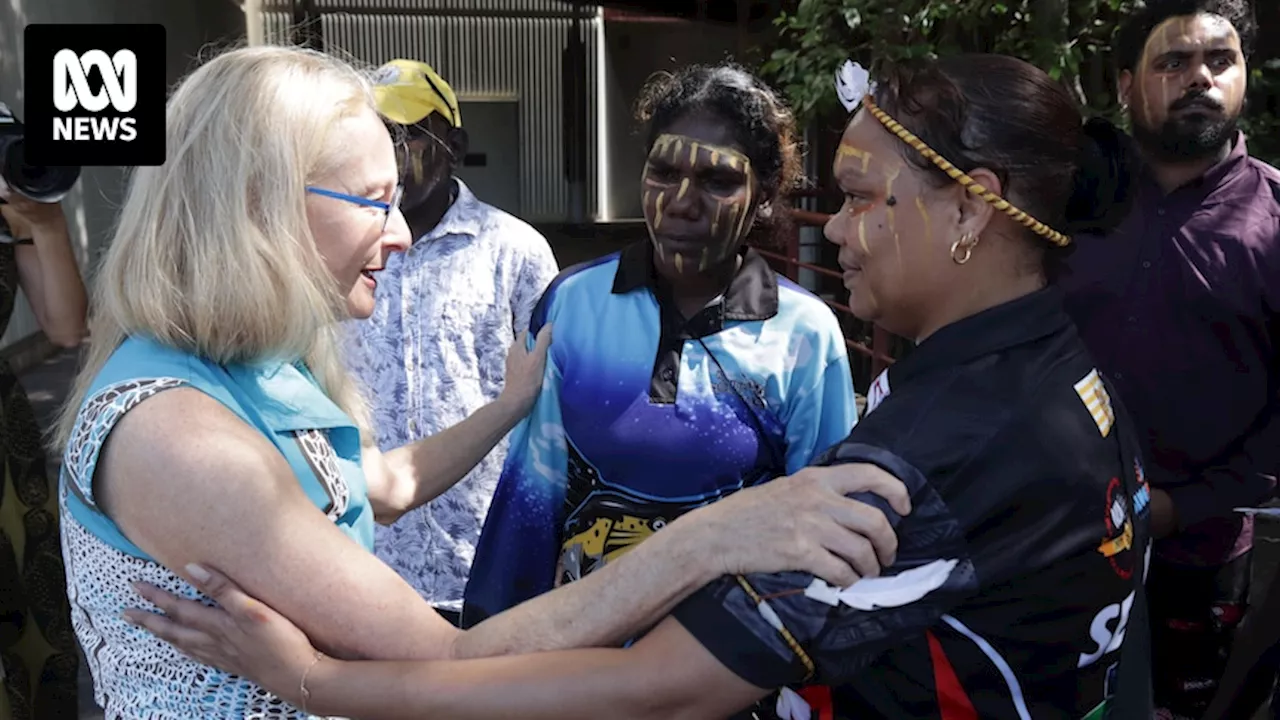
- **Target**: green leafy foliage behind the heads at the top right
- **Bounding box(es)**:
[762,0,1280,164]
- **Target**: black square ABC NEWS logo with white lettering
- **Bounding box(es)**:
[24,24,166,167]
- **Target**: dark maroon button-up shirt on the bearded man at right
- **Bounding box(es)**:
[1061,135,1280,565]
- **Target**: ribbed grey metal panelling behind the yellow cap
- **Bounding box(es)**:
[262,0,603,222]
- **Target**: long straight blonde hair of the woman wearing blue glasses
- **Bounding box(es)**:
[52,46,374,451]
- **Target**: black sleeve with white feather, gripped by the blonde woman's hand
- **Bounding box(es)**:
[673,442,978,688]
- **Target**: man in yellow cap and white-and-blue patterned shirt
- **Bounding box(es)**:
[348,60,558,623]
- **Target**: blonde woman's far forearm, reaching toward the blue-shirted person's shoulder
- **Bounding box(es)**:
[371,397,526,523]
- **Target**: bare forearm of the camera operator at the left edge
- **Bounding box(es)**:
[31,214,87,347]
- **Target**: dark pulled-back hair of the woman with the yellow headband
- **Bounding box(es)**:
[876,55,1133,279]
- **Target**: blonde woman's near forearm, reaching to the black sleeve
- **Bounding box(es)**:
[453,521,718,659]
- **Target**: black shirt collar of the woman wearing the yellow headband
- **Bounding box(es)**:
[890,287,1071,384]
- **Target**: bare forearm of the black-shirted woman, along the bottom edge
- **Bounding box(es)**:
[307,650,672,720]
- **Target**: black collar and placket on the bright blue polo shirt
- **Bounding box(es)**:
[613,241,778,405]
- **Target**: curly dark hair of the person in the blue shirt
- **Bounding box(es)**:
[636,63,801,212]
